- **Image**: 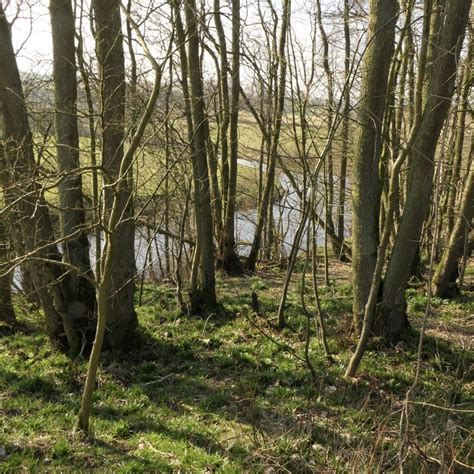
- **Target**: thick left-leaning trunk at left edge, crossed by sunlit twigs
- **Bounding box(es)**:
[0,5,79,349]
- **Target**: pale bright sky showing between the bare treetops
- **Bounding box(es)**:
[4,0,370,104]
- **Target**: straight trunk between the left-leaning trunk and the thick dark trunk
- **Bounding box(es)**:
[50,0,95,344]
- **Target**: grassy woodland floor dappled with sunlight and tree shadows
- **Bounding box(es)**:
[0,264,474,473]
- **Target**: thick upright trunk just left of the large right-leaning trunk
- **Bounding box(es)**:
[352,0,397,331]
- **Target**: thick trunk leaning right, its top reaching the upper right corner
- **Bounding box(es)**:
[377,0,470,340]
